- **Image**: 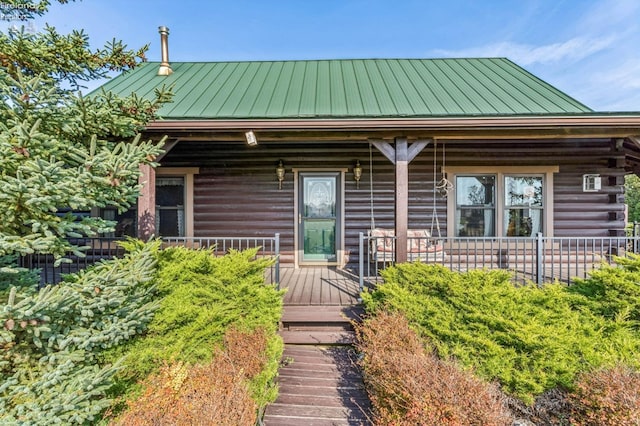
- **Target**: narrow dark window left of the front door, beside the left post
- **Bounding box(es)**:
[156,176,185,237]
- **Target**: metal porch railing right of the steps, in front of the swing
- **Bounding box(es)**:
[359,233,640,289]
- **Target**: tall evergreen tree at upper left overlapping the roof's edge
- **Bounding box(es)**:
[0,0,170,258]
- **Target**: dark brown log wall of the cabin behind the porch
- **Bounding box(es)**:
[162,139,625,262]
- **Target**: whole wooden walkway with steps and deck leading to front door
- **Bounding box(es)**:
[263,274,372,426]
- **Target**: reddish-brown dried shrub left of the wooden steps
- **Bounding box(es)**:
[114,328,270,426]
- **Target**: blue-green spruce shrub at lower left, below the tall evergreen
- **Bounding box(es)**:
[0,242,159,424]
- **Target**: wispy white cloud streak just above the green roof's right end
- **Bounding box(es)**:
[434,35,617,66]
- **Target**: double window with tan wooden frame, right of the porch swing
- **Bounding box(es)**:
[447,167,558,237]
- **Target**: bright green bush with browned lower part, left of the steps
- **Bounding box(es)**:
[106,247,283,424]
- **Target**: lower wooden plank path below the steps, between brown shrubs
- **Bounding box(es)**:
[264,345,372,426]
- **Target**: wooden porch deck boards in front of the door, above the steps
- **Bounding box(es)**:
[280,266,368,306]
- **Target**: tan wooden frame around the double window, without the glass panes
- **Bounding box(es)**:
[443,165,559,238]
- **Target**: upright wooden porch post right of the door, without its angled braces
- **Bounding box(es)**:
[395,137,409,263]
